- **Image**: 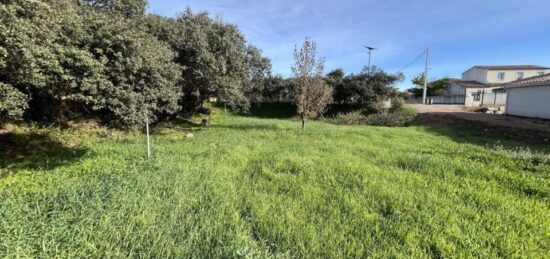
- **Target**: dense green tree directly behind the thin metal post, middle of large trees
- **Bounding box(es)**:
[84,9,182,127]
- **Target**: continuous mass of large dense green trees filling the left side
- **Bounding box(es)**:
[0,0,271,128]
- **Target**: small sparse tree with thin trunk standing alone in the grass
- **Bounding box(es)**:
[292,38,332,130]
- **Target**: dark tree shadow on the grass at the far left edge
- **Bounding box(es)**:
[0,132,88,173]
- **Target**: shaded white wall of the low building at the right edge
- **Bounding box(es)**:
[506,85,550,119]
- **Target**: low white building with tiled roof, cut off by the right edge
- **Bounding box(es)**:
[504,74,550,119]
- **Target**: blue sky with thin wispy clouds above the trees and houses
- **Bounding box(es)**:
[149,0,550,88]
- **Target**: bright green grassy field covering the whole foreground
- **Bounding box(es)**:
[0,107,550,258]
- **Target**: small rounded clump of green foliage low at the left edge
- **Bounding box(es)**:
[0,83,28,124]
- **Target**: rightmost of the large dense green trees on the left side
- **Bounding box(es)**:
[148,8,271,113]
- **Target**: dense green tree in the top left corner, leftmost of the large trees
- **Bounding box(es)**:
[0,0,108,124]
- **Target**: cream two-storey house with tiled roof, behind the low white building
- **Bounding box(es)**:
[447,65,550,107]
